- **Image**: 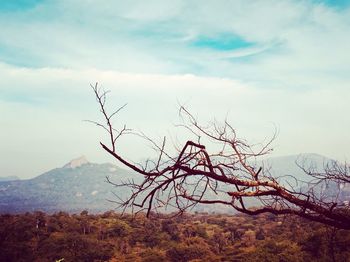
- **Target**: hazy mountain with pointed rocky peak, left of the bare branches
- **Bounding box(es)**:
[0,157,138,213]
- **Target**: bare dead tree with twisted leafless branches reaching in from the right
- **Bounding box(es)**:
[92,84,350,229]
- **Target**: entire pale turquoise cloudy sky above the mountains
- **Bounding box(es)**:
[0,0,350,178]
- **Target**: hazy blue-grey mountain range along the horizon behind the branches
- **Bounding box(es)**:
[0,154,350,213]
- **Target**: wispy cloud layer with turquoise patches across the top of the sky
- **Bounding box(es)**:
[0,0,350,87]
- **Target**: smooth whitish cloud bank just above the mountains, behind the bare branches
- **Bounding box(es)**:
[0,65,350,177]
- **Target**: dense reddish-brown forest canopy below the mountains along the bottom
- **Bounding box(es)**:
[0,211,350,262]
